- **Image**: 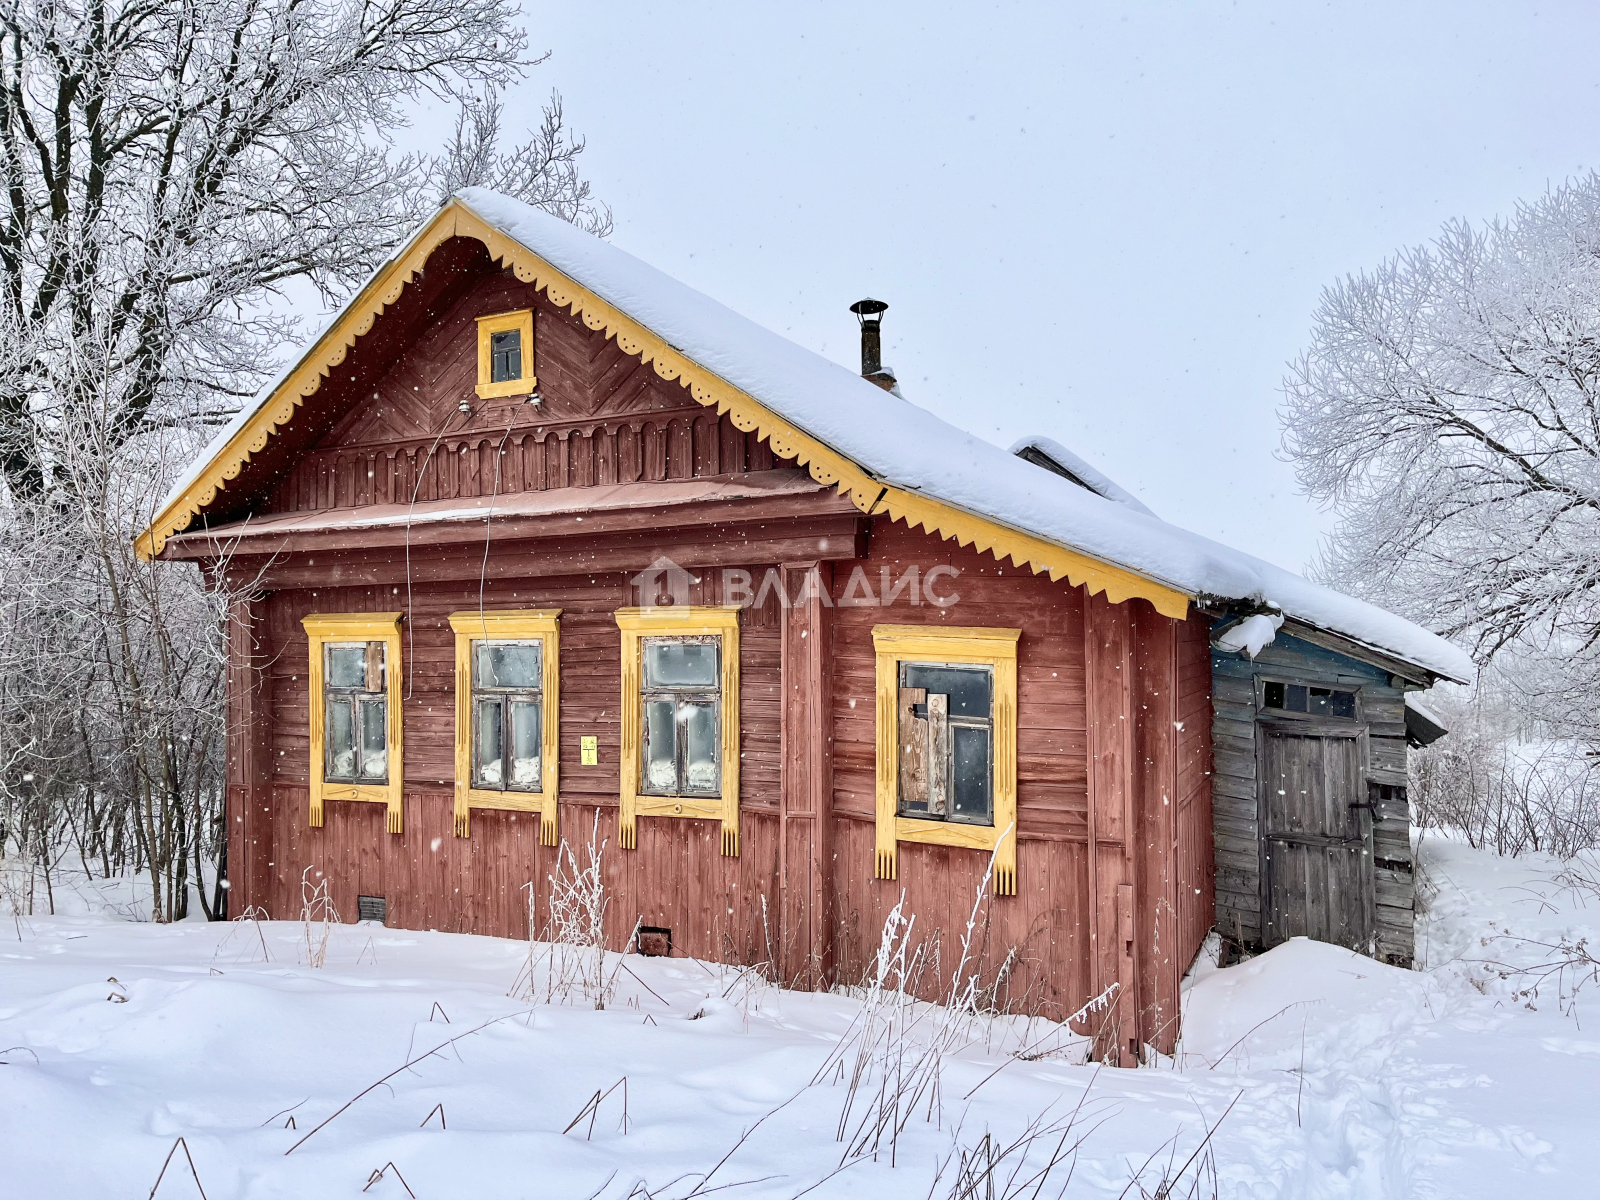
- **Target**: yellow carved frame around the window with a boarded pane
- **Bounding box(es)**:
[872,626,1022,896]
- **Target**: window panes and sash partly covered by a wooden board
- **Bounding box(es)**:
[898,662,994,826]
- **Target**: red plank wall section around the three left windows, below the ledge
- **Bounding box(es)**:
[254,568,781,963]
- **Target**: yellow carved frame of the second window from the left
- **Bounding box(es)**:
[450,608,562,846]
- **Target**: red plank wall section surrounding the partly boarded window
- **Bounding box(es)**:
[832,520,1210,1048]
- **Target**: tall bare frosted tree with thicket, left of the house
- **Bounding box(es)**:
[0,0,610,920]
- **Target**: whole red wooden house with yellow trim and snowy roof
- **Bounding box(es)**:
[139,190,1467,1061]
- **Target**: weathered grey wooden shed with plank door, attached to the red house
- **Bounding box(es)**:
[1211,618,1443,966]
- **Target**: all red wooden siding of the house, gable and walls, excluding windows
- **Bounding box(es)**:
[209,232,1213,1061]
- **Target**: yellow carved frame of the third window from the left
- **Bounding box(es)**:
[616,605,739,858]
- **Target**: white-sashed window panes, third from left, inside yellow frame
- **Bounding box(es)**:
[638,634,722,797]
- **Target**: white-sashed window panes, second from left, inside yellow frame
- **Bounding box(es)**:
[472,638,544,792]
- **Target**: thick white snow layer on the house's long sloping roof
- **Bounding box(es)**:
[147,187,1474,680]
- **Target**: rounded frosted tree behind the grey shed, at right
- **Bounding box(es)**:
[1285,173,1600,738]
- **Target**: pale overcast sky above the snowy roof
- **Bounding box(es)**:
[428,0,1600,570]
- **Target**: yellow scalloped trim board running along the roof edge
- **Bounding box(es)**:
[136,200,1189,621]
